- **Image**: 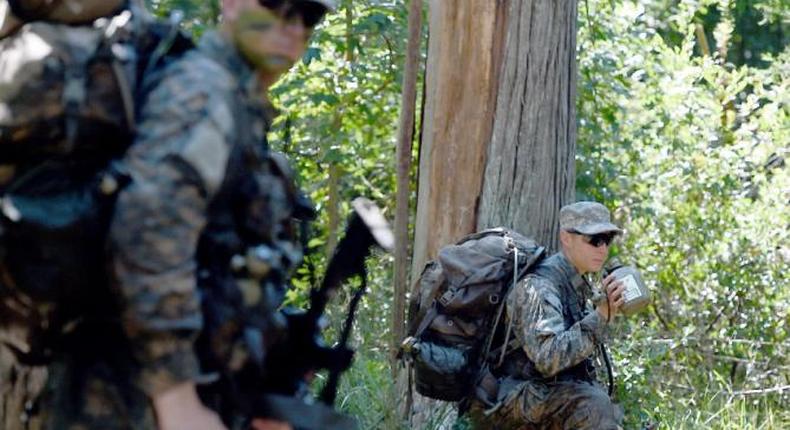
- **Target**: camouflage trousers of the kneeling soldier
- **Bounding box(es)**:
[467,381,623,430]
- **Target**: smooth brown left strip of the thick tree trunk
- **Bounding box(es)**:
[412,0,507,279]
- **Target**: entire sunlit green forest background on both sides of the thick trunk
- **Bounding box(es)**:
[149,0,790,429]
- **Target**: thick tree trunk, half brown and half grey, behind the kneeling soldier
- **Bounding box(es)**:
[411,0,576,428]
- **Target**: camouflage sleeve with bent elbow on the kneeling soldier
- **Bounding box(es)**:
[507,276,606,377]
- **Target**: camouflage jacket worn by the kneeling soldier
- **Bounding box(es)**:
[507,253,606,380]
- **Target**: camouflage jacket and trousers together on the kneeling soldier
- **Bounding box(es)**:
[470,253,622,430]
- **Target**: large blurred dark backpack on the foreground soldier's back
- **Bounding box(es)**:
[0,0,192,364]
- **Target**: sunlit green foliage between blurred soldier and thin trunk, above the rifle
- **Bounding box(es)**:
[272,1,406,207]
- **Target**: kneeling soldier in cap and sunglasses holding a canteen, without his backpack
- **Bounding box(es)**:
[470,202,624,430]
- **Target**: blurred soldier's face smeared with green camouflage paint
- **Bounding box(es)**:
[223,0,311,83]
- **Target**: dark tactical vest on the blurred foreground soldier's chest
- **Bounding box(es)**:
[186,58,314,390]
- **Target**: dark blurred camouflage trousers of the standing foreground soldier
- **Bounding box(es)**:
[0,324,156,430]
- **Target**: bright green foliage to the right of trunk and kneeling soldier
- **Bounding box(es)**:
[577,1,790,428]
